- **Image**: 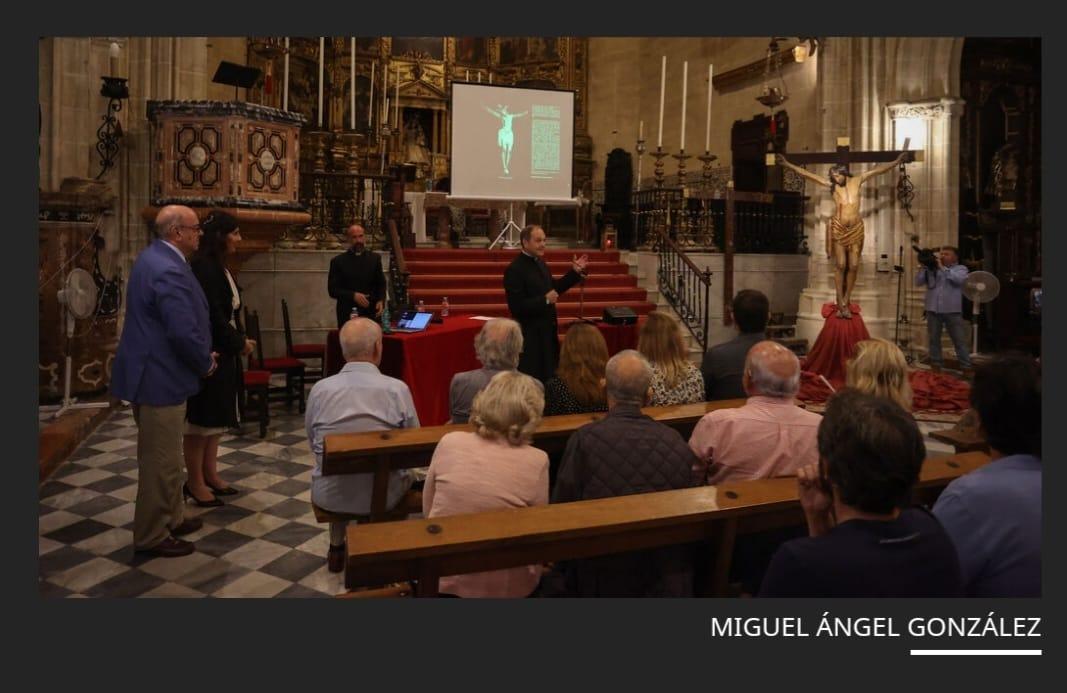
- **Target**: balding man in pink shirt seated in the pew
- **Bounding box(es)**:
[689,342,823,484]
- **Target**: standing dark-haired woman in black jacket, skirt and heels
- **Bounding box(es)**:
[182,210,255,507]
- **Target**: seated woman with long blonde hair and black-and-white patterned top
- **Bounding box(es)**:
[637,311,704,407]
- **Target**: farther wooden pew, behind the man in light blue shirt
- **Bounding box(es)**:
[322,399,745,521]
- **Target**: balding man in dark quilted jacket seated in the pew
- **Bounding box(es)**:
[545,349,695,597]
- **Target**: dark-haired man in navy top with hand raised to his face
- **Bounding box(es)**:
[760,390,962,597]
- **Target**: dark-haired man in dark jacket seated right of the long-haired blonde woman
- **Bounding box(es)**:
[700,288,770,401]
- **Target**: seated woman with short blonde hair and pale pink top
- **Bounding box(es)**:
[423,371,548,597]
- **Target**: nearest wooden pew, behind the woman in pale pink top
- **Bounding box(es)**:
[345,453,989,597]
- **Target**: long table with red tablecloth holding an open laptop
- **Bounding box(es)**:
[323,315,637,426]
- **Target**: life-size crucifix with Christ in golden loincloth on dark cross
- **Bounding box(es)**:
[776,138,914,318]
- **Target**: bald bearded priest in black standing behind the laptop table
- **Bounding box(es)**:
[327,224,385,329]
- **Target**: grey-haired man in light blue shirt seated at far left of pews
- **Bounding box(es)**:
[304,317,418,572]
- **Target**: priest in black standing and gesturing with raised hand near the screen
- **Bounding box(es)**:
[504,226,589,382]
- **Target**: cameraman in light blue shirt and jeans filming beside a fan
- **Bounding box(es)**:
[915,246,972,375]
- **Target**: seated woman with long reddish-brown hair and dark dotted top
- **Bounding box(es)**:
[544,322,607,416]
